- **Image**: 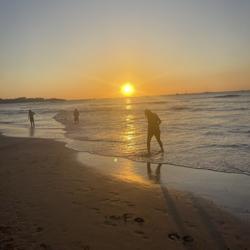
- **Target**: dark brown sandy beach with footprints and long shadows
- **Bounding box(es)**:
[0,136,250,250]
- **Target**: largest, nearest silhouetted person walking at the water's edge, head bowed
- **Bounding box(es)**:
[144,109,164,154]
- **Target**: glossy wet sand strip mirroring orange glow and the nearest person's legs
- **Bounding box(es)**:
[75,149,250,224]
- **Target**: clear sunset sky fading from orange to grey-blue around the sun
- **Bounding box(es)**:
[0,0,250,99]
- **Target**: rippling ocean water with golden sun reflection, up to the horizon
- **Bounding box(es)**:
[0,91,250,175]
